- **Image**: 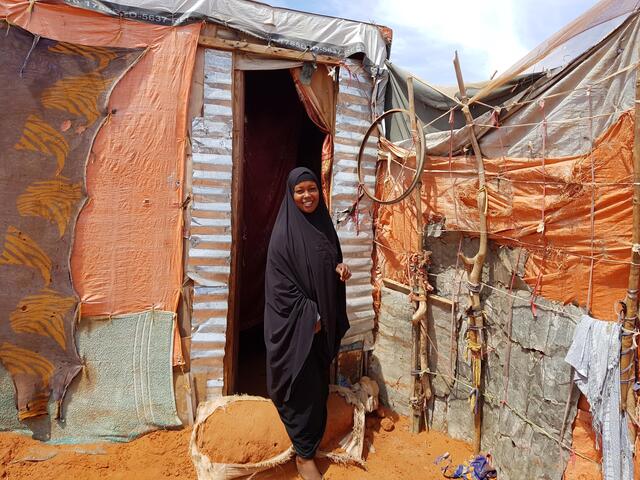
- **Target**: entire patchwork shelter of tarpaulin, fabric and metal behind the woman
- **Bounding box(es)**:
[0,0,639,479]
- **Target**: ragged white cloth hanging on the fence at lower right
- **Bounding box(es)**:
[565,315,633,480]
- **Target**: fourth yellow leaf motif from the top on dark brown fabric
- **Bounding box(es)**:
[18,177,82,238]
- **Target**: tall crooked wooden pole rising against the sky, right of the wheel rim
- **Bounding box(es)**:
[453,52,488,453]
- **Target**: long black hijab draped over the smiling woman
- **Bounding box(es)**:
[264,167,349,404]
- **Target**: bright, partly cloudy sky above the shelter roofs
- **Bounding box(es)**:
[263,0,597,85]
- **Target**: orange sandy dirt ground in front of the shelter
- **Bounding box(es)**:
[0,410,472,480]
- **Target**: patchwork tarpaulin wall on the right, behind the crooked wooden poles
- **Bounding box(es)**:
[371,1,640,479]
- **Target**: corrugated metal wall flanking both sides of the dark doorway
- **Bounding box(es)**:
[187,49,377,399]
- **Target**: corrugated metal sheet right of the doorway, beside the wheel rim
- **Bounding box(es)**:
[331,61,378,344]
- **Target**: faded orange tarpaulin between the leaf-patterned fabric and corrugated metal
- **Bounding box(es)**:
[0,0,200,316]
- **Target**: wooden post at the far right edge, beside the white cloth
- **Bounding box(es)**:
[620,70,640,441]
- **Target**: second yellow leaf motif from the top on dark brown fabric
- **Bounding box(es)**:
[41,72,111,125]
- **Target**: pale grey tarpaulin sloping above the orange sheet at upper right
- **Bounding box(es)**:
[481,14,640,158]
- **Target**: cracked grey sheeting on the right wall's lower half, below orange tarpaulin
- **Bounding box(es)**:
[369,237,580,480]
